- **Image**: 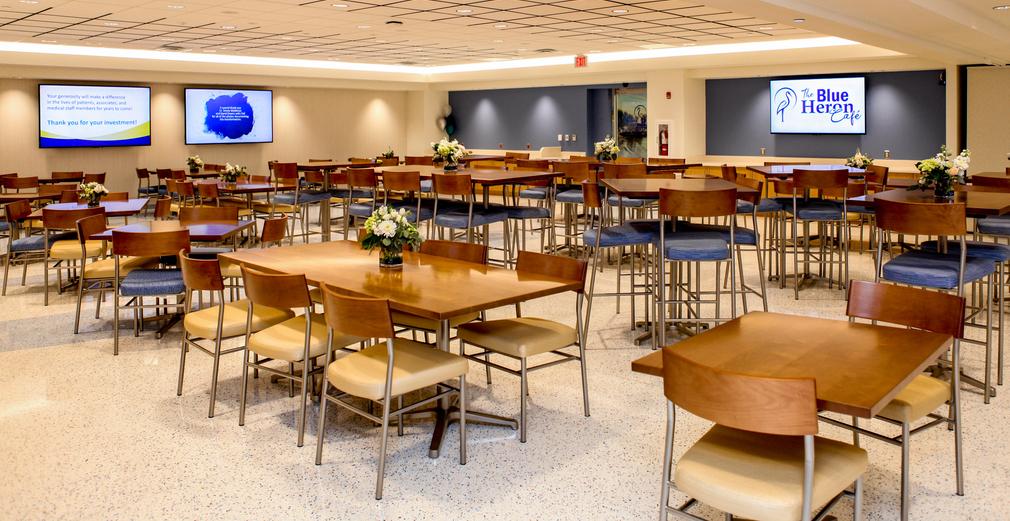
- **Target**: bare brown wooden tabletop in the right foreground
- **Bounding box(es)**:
[631,312,951,418]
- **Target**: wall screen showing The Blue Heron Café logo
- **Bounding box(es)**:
[770,77,867,134]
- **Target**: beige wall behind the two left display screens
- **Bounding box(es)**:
[0,79,407,191]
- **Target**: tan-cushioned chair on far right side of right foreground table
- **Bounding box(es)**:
[821,281,965,520]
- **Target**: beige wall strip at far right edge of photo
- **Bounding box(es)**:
[968,67,1010,172]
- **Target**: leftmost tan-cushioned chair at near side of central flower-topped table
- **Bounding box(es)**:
[176,252,295,418]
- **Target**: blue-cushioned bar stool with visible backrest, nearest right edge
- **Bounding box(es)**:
[874,198,1002,404]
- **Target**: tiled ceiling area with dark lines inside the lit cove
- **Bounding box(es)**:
[0,0,817,66]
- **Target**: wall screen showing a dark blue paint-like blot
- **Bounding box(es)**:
[186,89,274,144]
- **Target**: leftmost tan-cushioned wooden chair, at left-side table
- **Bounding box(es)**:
[42,207,106,306]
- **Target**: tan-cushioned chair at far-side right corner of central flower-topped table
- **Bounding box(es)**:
[457,251,589,443]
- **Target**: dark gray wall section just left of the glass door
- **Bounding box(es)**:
[448,84,643,152]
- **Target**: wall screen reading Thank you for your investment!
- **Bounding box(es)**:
[38,84,150,148]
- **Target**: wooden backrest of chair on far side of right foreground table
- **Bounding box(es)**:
[845,281,965,338]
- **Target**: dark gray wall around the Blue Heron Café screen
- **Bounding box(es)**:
[705,71,946,160]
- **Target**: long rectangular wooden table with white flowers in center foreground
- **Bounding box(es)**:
[218,240,579,457]
